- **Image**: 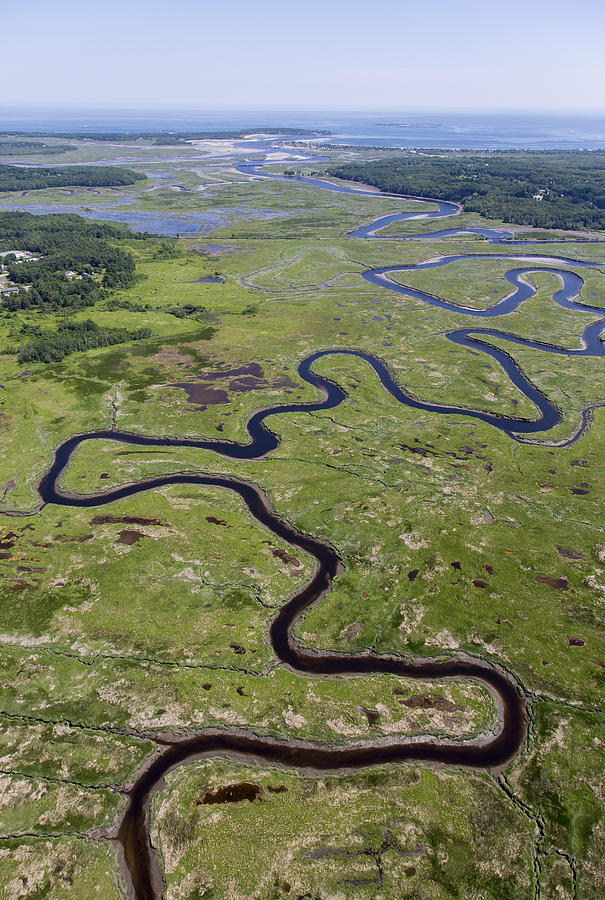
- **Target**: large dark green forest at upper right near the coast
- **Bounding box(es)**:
[328,150,605,230]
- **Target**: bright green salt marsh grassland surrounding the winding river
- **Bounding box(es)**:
[0,139,605,900]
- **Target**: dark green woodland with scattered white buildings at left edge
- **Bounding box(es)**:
[0,212,150,312]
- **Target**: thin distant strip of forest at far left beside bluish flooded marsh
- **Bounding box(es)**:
[0,165,147,191]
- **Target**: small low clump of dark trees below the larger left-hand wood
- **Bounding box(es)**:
[17,319,151,363]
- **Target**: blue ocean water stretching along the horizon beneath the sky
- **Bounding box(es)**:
[0,108,605,150]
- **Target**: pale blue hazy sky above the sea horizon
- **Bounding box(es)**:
[0,0,605,112]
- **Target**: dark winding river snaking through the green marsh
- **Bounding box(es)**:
[29,158,605,900]
